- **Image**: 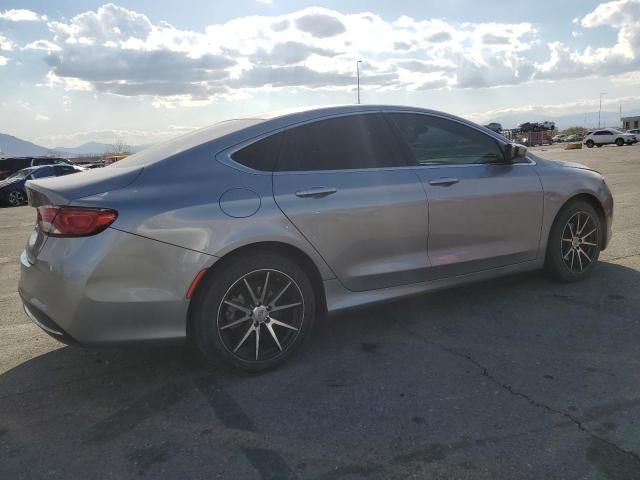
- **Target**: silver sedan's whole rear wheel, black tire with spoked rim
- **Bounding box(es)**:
[190,253,316,372]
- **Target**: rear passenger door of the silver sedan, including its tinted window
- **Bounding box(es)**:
[273,113,429,291]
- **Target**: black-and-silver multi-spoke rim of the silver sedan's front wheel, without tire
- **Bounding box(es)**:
[560,212,600,273]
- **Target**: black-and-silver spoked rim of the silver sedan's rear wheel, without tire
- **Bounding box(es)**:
[217,269,304,362]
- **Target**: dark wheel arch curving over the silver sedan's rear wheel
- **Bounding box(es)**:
[187,241,327,336]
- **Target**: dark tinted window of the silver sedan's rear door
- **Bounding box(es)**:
[278,114,401,171]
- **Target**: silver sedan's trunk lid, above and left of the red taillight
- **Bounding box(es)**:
[25,166,144,263]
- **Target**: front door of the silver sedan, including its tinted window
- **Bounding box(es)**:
[388,113,543,278]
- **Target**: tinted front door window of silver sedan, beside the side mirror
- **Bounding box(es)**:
[389,113,504,165]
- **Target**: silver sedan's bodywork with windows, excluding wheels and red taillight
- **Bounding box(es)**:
[19,105,613,372]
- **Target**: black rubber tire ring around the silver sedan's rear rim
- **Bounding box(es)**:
[190,253,316,372]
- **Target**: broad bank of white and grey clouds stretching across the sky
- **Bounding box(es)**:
[16,0,640,107]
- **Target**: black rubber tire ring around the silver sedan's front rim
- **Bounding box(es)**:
[545,200,603,282]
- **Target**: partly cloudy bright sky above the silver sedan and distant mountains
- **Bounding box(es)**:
[0,0,640,148]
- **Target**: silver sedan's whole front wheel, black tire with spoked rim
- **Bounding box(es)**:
[545,200,604,282]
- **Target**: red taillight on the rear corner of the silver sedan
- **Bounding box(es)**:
[38,206,118,237]
